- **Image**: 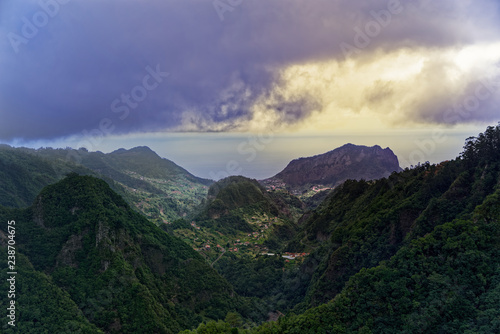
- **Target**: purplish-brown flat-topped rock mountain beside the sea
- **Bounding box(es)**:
[273,144,401,187]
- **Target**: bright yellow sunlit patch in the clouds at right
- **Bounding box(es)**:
[235,43,500,132]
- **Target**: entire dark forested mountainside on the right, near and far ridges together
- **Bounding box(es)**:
[182,126,500,334]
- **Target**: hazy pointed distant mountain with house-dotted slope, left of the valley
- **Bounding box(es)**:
[61,146,213,224]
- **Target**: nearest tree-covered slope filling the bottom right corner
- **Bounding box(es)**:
[252,191,500,333]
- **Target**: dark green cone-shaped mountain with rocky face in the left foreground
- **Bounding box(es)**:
[0,174,264,333]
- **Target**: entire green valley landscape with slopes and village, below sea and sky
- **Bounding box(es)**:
[0,125,500,334]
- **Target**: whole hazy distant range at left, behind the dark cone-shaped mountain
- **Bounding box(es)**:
[0,145,213,224]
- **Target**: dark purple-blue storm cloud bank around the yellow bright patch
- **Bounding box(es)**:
[0,0,498,140]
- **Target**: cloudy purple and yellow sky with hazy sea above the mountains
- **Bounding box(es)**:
[0,0,500,179]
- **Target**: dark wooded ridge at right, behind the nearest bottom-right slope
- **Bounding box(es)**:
[287,126,500,308]
